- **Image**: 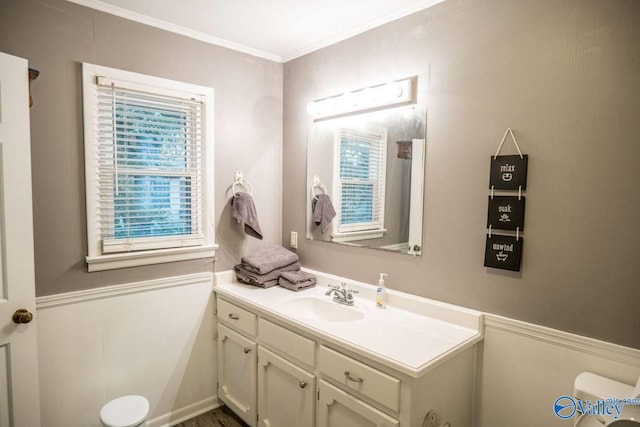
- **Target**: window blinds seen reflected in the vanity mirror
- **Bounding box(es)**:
[338,128,386,232]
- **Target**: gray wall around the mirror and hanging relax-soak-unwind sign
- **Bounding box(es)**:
[283,0,640,348]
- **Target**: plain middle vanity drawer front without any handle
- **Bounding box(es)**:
[258,318,316,366]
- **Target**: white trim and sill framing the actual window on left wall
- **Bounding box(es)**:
[82,63,218,272]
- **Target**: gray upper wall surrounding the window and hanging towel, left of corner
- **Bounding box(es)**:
[0,0,282,296]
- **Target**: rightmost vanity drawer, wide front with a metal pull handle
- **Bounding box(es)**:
[318,346,400,412]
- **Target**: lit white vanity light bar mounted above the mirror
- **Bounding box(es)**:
[307,76,418,121]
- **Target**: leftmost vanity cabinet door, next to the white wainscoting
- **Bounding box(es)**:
[218,324,257,427]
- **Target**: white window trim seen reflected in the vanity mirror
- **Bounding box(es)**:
[331,125,387,243]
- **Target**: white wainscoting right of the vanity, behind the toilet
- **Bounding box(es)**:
[476,314,640,427]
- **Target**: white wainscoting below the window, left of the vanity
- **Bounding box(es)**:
[37,273,220,427]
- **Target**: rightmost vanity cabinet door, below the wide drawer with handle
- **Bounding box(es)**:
[317,381,400,427]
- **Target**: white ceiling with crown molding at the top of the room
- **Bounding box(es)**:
[68,0,443,62]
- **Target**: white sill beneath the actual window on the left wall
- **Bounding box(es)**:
[86,245,218,272]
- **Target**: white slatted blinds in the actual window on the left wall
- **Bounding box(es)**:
[97,78,204,253]
